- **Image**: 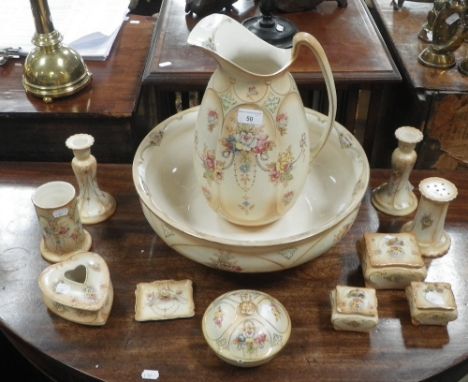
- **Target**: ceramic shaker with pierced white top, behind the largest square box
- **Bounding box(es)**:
[401,177,458,257]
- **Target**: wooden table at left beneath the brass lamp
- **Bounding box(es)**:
[0,16,155,163]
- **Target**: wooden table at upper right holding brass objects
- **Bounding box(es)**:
[373,0,468,169]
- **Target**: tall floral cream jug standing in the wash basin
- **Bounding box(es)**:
[188,14,336,226]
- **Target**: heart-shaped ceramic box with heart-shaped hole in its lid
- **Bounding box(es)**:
[39,252,113,325]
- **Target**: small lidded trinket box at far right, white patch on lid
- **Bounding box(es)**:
[405,281,458,325]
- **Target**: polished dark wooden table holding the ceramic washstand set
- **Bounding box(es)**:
[0,163,468,382]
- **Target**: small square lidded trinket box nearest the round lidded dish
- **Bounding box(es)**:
[330,285,379,332]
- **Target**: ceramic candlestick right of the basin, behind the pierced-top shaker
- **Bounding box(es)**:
[372,126,423,216]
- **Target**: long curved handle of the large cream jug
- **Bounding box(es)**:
[292,32,337,163]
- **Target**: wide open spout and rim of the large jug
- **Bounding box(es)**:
[187,13,292,78]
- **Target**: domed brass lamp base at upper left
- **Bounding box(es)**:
[23,30,92,102]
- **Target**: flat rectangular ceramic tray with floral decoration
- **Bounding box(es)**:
[135,280,195,321]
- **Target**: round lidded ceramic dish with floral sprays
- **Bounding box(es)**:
[202,289,291,367]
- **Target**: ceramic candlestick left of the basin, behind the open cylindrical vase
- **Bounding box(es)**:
[65,134,116,224]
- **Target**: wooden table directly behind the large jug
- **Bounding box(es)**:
[143,0,401,163]
